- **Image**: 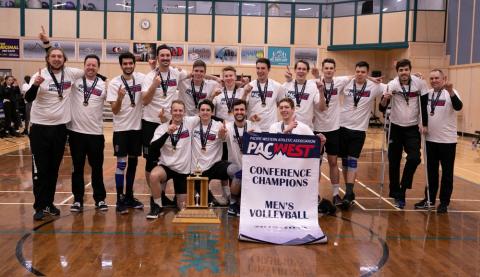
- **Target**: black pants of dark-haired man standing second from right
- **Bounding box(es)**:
[388,123,420,199]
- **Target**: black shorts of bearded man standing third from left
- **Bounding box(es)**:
[113,130,142,157]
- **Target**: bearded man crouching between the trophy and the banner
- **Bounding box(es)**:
[219,99,260,216]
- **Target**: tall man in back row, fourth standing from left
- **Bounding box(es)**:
[142,44,187,205]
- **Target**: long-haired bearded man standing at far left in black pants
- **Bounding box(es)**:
[25,47,83,220]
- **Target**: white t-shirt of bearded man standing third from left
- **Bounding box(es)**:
[107,72,145,132]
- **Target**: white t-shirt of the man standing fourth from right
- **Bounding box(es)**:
[313,76,352,132]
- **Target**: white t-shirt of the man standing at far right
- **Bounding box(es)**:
[425,89,460,143]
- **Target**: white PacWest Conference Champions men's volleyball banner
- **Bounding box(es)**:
[239,133,327,245]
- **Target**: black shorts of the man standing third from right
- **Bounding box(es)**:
[339,127,366,159]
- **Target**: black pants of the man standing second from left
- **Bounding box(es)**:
[68,131,107,204]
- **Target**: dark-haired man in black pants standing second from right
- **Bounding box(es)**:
[380,59,428,209]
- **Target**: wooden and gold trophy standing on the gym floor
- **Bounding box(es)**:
[172,164,220,224]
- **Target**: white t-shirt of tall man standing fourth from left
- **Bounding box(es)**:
[142,67,187,123]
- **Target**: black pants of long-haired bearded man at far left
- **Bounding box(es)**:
[30,124,67,210]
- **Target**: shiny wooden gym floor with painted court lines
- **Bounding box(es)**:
[0,126,480,276]
